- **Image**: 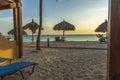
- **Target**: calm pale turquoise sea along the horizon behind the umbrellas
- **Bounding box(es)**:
[5,34,104,42]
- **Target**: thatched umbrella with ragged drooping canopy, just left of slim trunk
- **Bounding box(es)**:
[23,19,39,42]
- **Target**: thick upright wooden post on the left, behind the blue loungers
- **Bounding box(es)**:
[13,0,23,58]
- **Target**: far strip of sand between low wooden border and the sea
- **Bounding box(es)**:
[24,41,107,49]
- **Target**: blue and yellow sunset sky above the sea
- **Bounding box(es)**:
[0,0,108,35]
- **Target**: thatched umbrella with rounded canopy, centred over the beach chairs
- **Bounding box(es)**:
[53,21,75,40]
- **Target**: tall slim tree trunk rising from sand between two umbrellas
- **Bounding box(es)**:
[36,0,42,50]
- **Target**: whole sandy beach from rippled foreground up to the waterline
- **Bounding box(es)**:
[5,41,107,80]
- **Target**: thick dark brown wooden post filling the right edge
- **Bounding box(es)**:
[107,0,120,80]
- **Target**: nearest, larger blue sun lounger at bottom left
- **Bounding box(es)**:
[0,62,37,80]
